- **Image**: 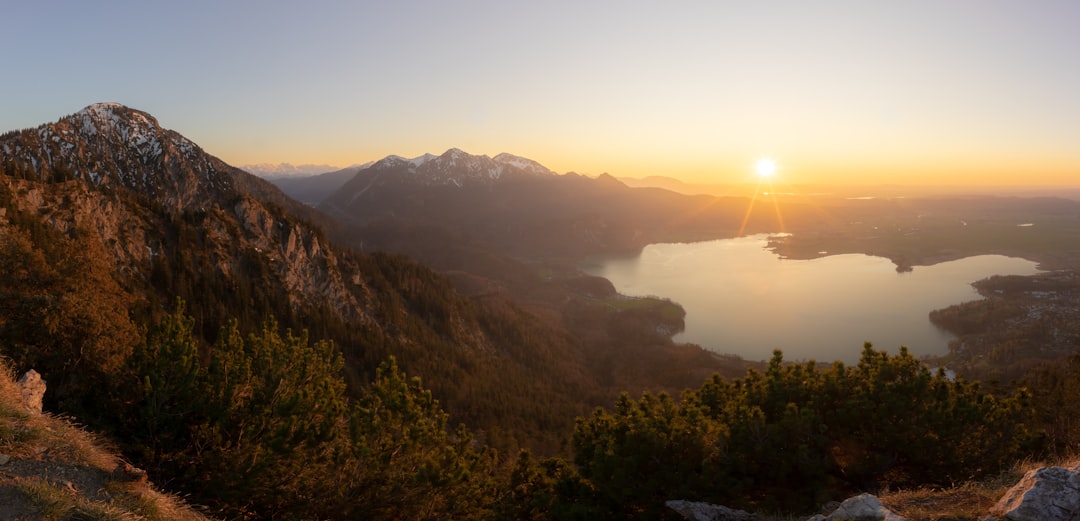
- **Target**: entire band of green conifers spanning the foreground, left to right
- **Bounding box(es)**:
[69,302,1045,519]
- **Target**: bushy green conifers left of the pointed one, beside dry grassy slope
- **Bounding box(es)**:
[129,304,348,518]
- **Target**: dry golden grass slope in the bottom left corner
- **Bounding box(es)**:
[0,361,216,521]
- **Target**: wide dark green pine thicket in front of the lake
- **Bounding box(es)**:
[573,344,1036,519]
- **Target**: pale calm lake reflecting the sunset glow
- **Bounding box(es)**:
[582,236,1038,363]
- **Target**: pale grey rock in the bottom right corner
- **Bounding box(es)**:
[990,466,1080,521]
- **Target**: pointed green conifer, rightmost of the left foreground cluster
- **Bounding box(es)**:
[328,358,499,519]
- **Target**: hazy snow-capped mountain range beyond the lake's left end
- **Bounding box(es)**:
[319,149,799,264]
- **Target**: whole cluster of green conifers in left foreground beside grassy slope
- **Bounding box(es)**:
[127,303,499,519]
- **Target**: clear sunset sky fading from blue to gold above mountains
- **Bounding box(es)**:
[0,0,1080,185]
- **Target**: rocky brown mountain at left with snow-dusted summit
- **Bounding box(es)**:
[0,103,367,320]
